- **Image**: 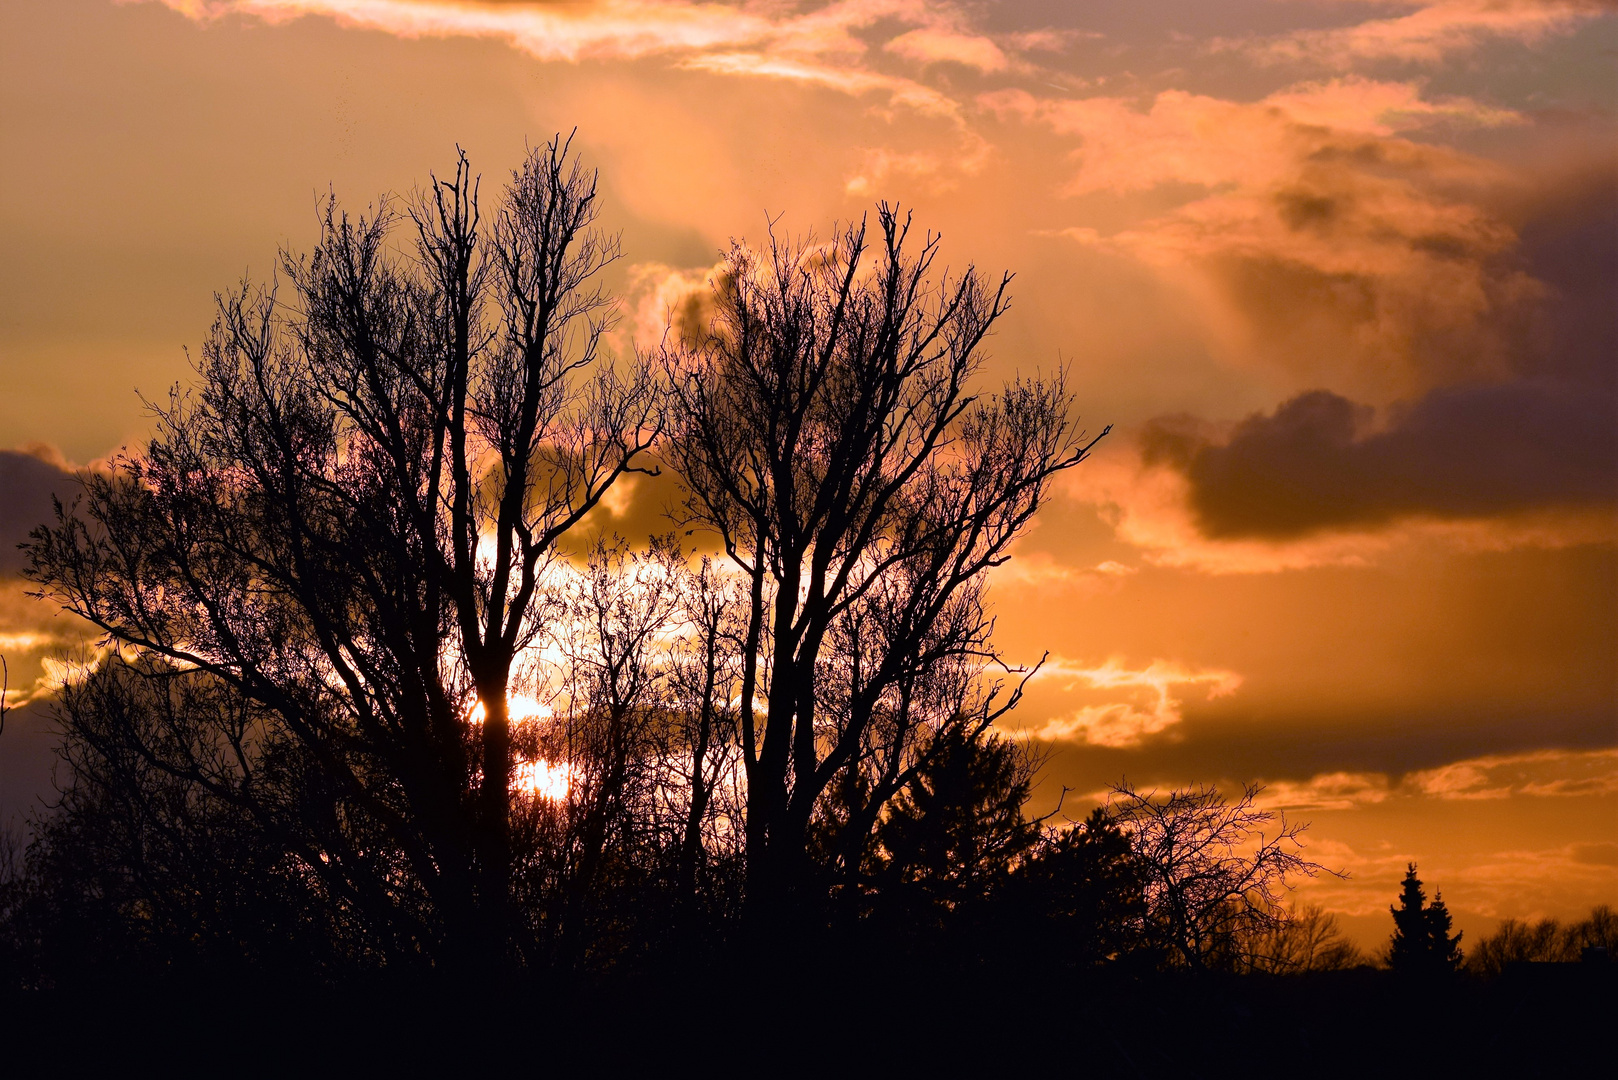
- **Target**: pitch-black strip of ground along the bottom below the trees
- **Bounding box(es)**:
[0,965,1618,1077]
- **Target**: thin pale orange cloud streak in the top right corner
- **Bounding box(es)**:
[1214,0,1615,68]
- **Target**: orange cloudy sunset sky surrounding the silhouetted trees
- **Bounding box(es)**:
[0,0,1618,946]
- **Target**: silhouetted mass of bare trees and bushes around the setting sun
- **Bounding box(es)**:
[0,141,1605,1068]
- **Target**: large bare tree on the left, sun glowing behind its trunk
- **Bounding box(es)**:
[32,139,657,963]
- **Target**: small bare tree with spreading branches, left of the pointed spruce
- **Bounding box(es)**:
[1107,782,1324,970]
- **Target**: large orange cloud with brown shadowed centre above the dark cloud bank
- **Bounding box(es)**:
[981,76,1542,403]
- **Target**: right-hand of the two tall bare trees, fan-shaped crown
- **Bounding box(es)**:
[663,206,1105,908]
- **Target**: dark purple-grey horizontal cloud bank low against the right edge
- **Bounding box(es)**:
[1144,381,1618,539]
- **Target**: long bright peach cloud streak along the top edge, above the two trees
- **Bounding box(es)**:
[147,0,1032,200]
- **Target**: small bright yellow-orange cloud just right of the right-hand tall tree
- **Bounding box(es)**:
[1029,657,1241,748]
